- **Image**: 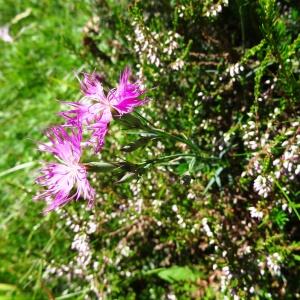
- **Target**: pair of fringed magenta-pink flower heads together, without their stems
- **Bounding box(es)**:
[36,68,146,212]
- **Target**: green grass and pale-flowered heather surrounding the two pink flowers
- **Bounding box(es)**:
[0,0,300,300]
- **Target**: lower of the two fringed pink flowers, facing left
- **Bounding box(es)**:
[36,126,95,212]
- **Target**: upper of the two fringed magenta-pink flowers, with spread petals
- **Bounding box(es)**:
[60,68,145,152]
